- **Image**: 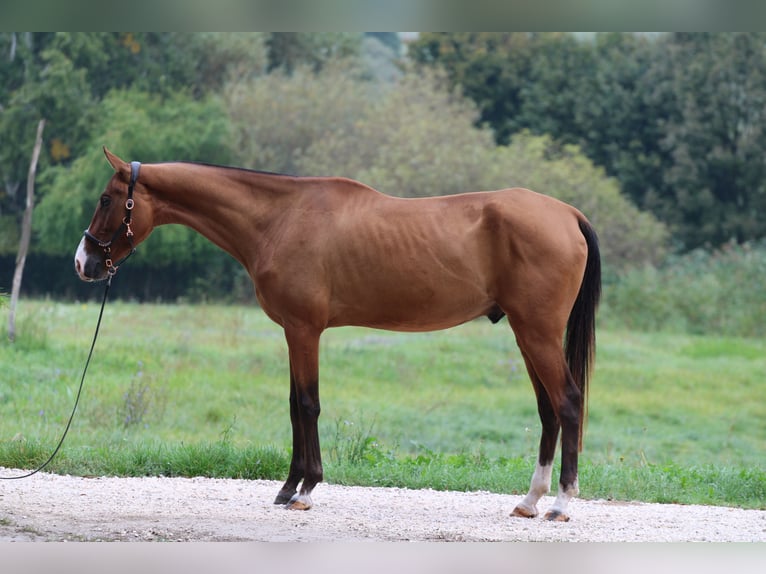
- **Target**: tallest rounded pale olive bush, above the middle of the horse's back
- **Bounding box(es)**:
[298,69,495,197]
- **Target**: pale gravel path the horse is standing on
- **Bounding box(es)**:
[0,469,766,542]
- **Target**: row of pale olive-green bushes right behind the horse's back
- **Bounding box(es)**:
[226,62,667,269]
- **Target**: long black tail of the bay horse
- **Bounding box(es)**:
[564,217,601,450]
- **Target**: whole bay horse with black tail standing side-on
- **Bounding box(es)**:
[75,148,601,521]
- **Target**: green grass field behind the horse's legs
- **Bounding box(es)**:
[0,301,766,508]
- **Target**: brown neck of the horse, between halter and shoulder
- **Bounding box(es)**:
[141,163,298,267]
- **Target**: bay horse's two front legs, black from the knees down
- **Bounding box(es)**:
[275,329,323,510]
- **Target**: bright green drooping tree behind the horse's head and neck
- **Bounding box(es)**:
[35,90,236,267]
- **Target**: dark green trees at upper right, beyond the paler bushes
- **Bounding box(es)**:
[410,33,766,249]
